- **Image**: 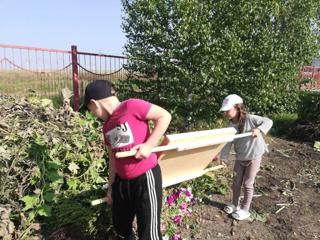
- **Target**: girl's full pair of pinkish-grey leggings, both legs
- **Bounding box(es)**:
[232,158,261,211]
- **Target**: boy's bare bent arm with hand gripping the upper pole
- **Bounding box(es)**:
[133,104,171,159]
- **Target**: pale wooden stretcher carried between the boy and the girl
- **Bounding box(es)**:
[91,127,252,205]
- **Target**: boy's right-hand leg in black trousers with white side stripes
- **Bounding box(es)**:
[136,165,162,240]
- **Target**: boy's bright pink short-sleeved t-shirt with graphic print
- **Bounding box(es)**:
[103,98,157,179]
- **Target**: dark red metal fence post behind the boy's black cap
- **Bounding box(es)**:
[71,45,80,111]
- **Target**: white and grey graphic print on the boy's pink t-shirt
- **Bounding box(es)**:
[105,122,134,148]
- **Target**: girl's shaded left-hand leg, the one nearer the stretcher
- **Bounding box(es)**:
[232,160,245,207]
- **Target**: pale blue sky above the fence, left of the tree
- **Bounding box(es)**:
[0,0,126,55]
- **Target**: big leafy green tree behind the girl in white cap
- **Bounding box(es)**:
[122,0,320,127]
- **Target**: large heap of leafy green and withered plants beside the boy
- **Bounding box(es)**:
[0,96,111,239]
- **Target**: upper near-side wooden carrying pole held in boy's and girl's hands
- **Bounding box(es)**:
[116,132,252,158]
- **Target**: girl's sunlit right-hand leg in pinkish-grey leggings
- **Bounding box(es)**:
[242,158,261,211]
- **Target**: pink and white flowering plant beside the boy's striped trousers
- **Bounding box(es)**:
[161,188,196,240]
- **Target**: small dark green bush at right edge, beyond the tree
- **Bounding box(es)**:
[298,92,320,123]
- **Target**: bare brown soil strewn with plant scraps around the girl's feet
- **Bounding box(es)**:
[190,138,320,240]
